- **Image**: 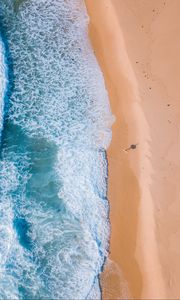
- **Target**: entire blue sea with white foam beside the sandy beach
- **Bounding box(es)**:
[0,0,113,300]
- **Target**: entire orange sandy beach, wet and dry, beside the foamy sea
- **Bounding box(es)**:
[86,0,180,299]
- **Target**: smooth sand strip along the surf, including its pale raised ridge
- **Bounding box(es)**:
[86,0,165,299]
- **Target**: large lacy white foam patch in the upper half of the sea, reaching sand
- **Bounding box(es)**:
[4,0,113,148]
